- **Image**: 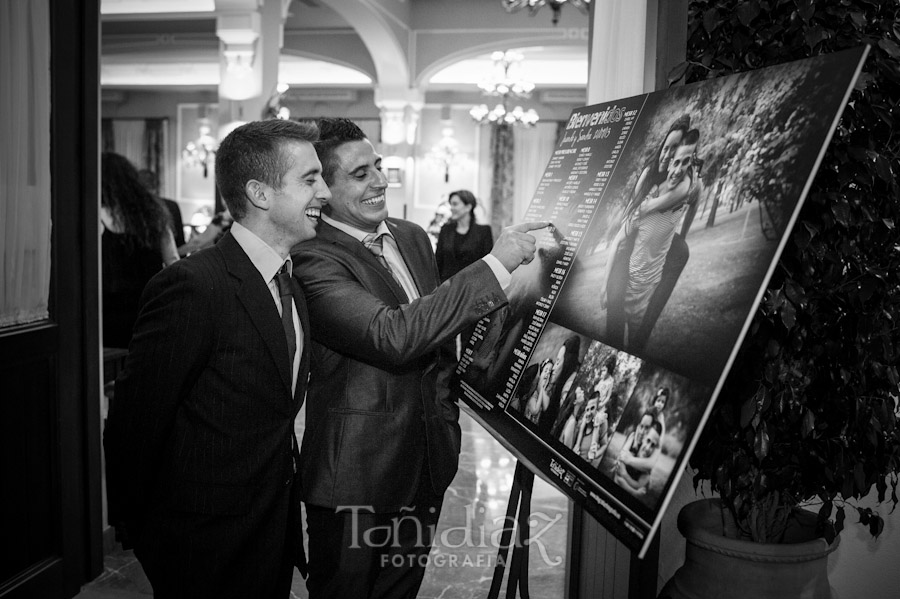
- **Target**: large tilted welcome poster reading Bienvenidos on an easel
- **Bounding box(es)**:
[456,48,867,557]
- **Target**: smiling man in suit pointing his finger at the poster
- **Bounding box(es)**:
[292,119,546,599]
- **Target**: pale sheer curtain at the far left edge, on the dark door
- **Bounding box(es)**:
[0,0,51,327]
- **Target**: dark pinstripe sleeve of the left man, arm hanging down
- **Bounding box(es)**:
[104,262,215,534]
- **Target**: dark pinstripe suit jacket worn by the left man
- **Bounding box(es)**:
[105,234,310,598]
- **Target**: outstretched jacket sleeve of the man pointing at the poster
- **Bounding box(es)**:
[294,246,507,368]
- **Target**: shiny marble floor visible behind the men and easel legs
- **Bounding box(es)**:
[76,413,569,599]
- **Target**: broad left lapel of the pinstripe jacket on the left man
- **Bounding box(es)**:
[216,234,299,395]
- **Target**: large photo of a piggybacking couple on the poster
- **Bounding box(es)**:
[550,54,860,384]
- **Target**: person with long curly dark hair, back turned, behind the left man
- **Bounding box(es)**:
[100,152,178,348]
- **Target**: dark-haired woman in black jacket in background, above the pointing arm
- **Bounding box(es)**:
[435,189,494,281]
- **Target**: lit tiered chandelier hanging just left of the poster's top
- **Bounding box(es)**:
[469,50,539,127]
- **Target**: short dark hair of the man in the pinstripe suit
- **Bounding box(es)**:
[216,119,318,222]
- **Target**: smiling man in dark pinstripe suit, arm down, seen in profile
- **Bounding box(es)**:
[105,120,330,599]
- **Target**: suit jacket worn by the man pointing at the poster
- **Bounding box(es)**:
[293,219,506,512]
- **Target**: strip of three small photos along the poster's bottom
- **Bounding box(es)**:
[507,324,711,510]
